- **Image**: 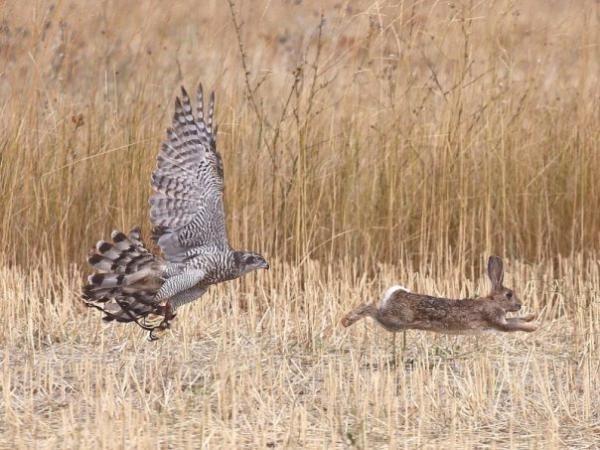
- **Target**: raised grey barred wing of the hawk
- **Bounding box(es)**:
[150,85,229,262]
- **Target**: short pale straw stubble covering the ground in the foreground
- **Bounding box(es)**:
[0,259,600,449]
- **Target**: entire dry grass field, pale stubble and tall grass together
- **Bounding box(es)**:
[0,0,600,449]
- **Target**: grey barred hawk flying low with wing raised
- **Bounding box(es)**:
[83,84,269,340]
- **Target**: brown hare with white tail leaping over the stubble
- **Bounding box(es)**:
[342,256,537,334]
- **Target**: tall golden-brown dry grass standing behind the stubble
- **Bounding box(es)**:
[0,0,600,276]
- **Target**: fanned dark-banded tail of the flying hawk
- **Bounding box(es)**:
[83,228,168,326]
